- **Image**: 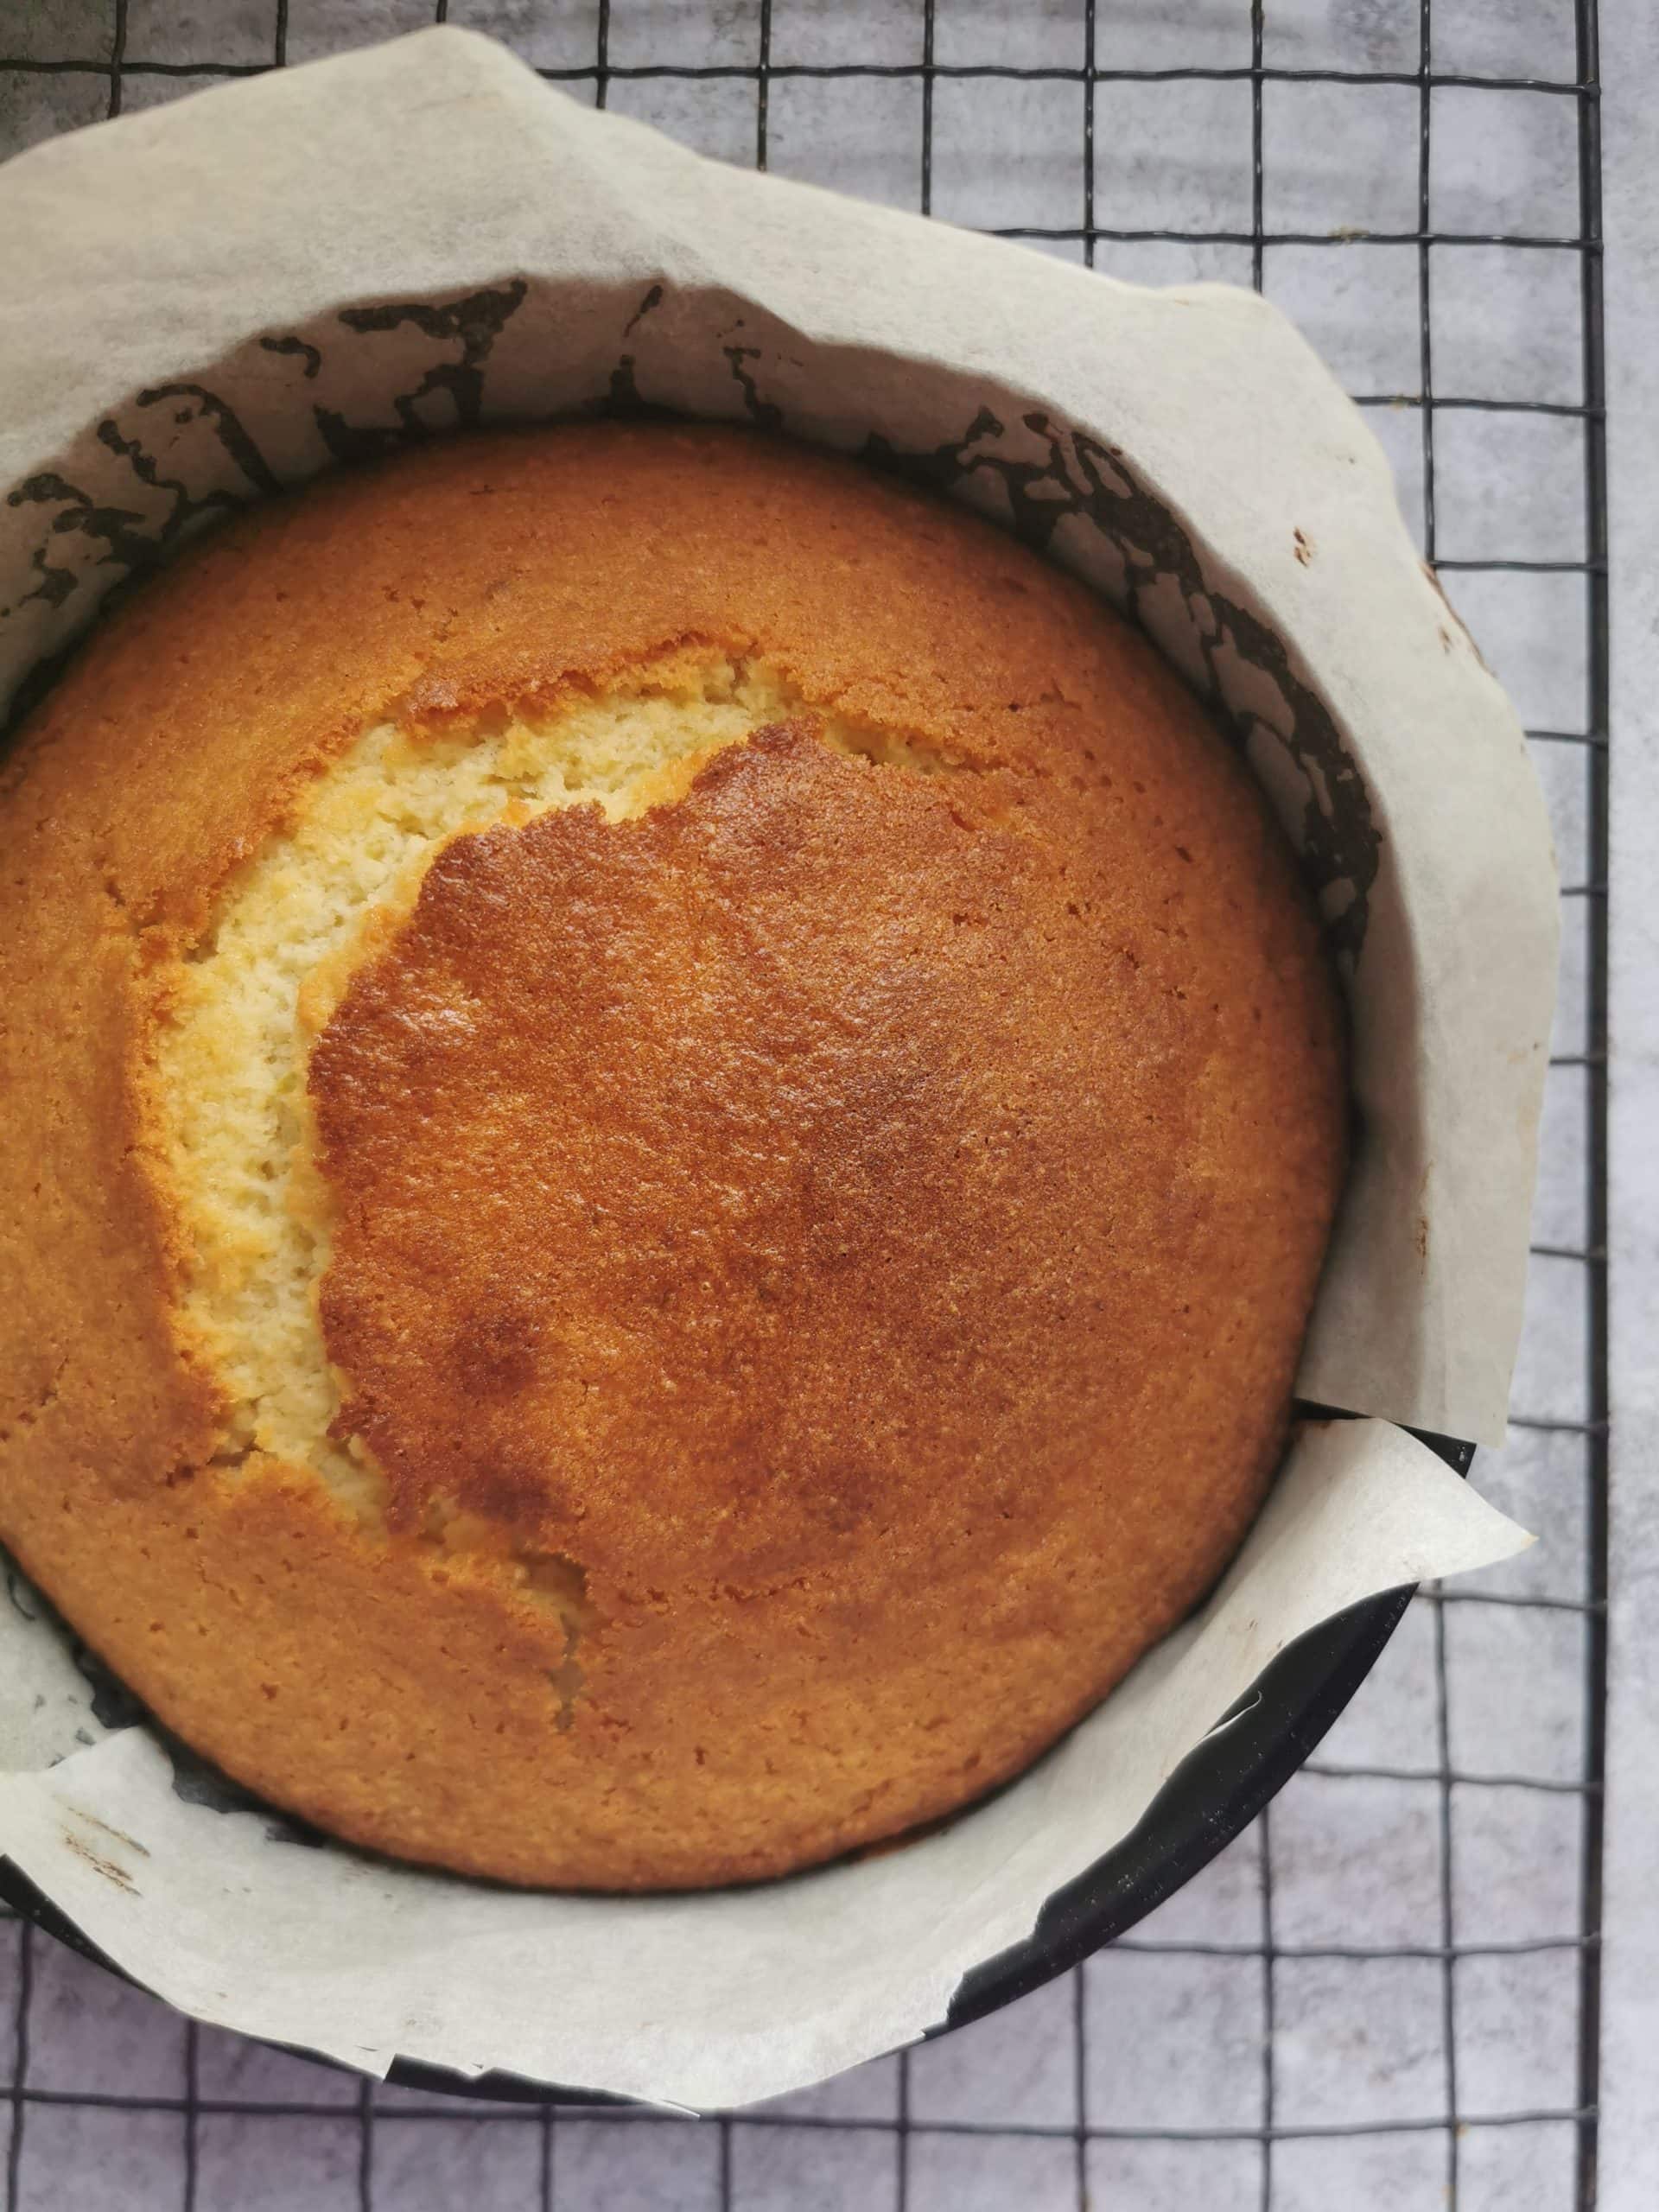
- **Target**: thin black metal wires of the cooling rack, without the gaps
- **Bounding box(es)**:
[0,0,1608,2212]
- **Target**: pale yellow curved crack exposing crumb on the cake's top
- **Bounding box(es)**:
[157,651,862,1516]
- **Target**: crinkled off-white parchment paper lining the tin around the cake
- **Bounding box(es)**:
[0,31,1555,2108]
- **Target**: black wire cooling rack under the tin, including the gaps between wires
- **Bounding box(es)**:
[0,0,1608,2212]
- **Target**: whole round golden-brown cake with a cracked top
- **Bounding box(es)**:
[0,425,1347,1889]
